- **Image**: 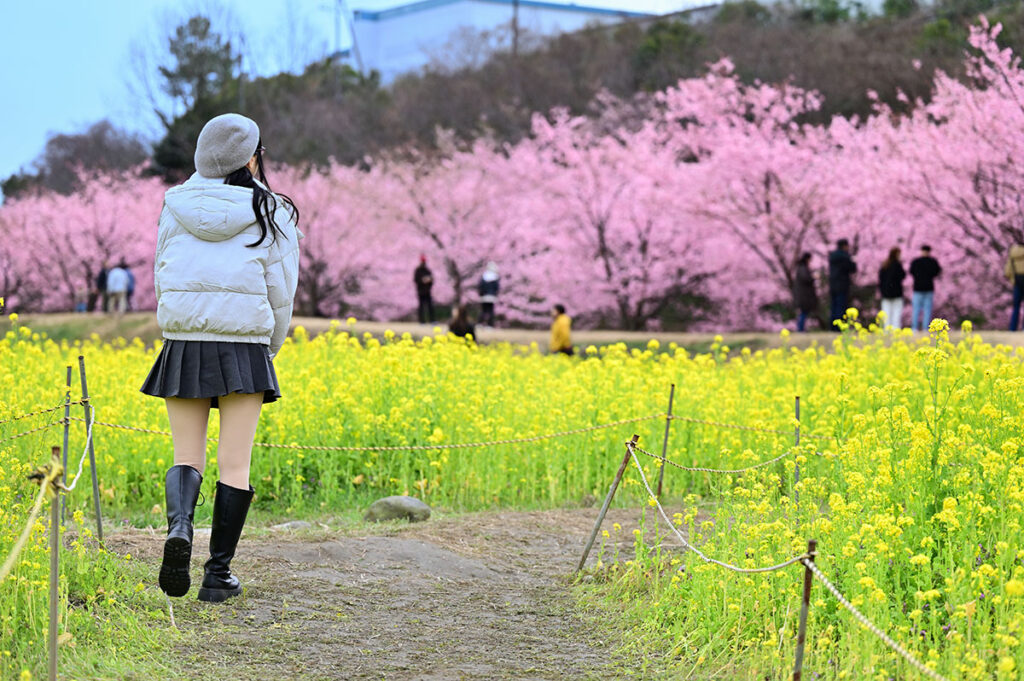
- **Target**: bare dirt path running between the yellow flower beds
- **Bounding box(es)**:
[108,509,638,681]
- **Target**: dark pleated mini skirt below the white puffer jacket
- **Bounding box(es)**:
[142,340,281,409]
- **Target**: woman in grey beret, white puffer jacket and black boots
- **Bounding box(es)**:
[142,114,302,602]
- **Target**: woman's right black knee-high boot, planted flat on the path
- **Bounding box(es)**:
[199,481,253,603]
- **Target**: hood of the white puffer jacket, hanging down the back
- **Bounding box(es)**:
[164,173,256,242]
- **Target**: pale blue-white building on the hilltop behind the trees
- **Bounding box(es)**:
[353,0,652,82]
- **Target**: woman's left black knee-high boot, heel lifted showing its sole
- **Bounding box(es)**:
[160,466,203,596]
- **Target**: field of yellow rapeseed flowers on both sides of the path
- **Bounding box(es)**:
[0,315,1024,681]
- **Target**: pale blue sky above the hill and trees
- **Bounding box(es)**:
[0,0,689,184]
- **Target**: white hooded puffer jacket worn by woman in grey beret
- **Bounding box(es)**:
[155,173,302,356]
